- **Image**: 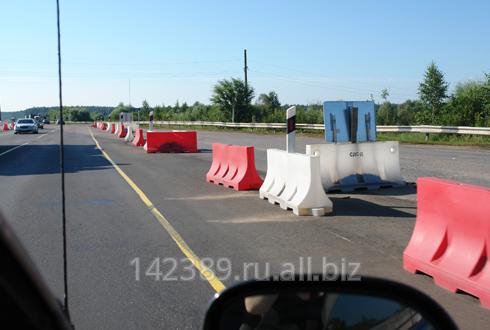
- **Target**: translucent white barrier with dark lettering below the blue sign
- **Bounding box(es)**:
[306,141,404,191]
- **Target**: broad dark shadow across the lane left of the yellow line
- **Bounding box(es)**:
[0,144,111,176]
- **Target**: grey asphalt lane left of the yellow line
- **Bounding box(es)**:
[0,126,213,329]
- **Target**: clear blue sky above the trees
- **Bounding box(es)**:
[0,0,490,111]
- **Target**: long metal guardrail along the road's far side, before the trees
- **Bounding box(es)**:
[129,121,490,136]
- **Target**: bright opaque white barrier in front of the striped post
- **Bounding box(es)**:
[259,149,332,216]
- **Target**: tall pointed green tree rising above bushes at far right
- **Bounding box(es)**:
[419,62,448,124]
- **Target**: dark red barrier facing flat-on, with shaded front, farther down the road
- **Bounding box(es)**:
[145,131,197,153]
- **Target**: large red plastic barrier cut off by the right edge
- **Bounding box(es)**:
[403,178,490,308]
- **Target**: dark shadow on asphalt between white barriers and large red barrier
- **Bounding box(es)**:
[329,196,415,219]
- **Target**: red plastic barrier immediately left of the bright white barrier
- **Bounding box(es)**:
[206,143,263,190]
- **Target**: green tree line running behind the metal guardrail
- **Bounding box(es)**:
[109,63,490,126]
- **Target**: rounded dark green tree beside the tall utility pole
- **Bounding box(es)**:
[211,78,254,122]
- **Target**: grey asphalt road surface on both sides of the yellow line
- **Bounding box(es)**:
[0,125,490,329]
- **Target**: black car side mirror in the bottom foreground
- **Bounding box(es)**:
[204,277,457,330]
